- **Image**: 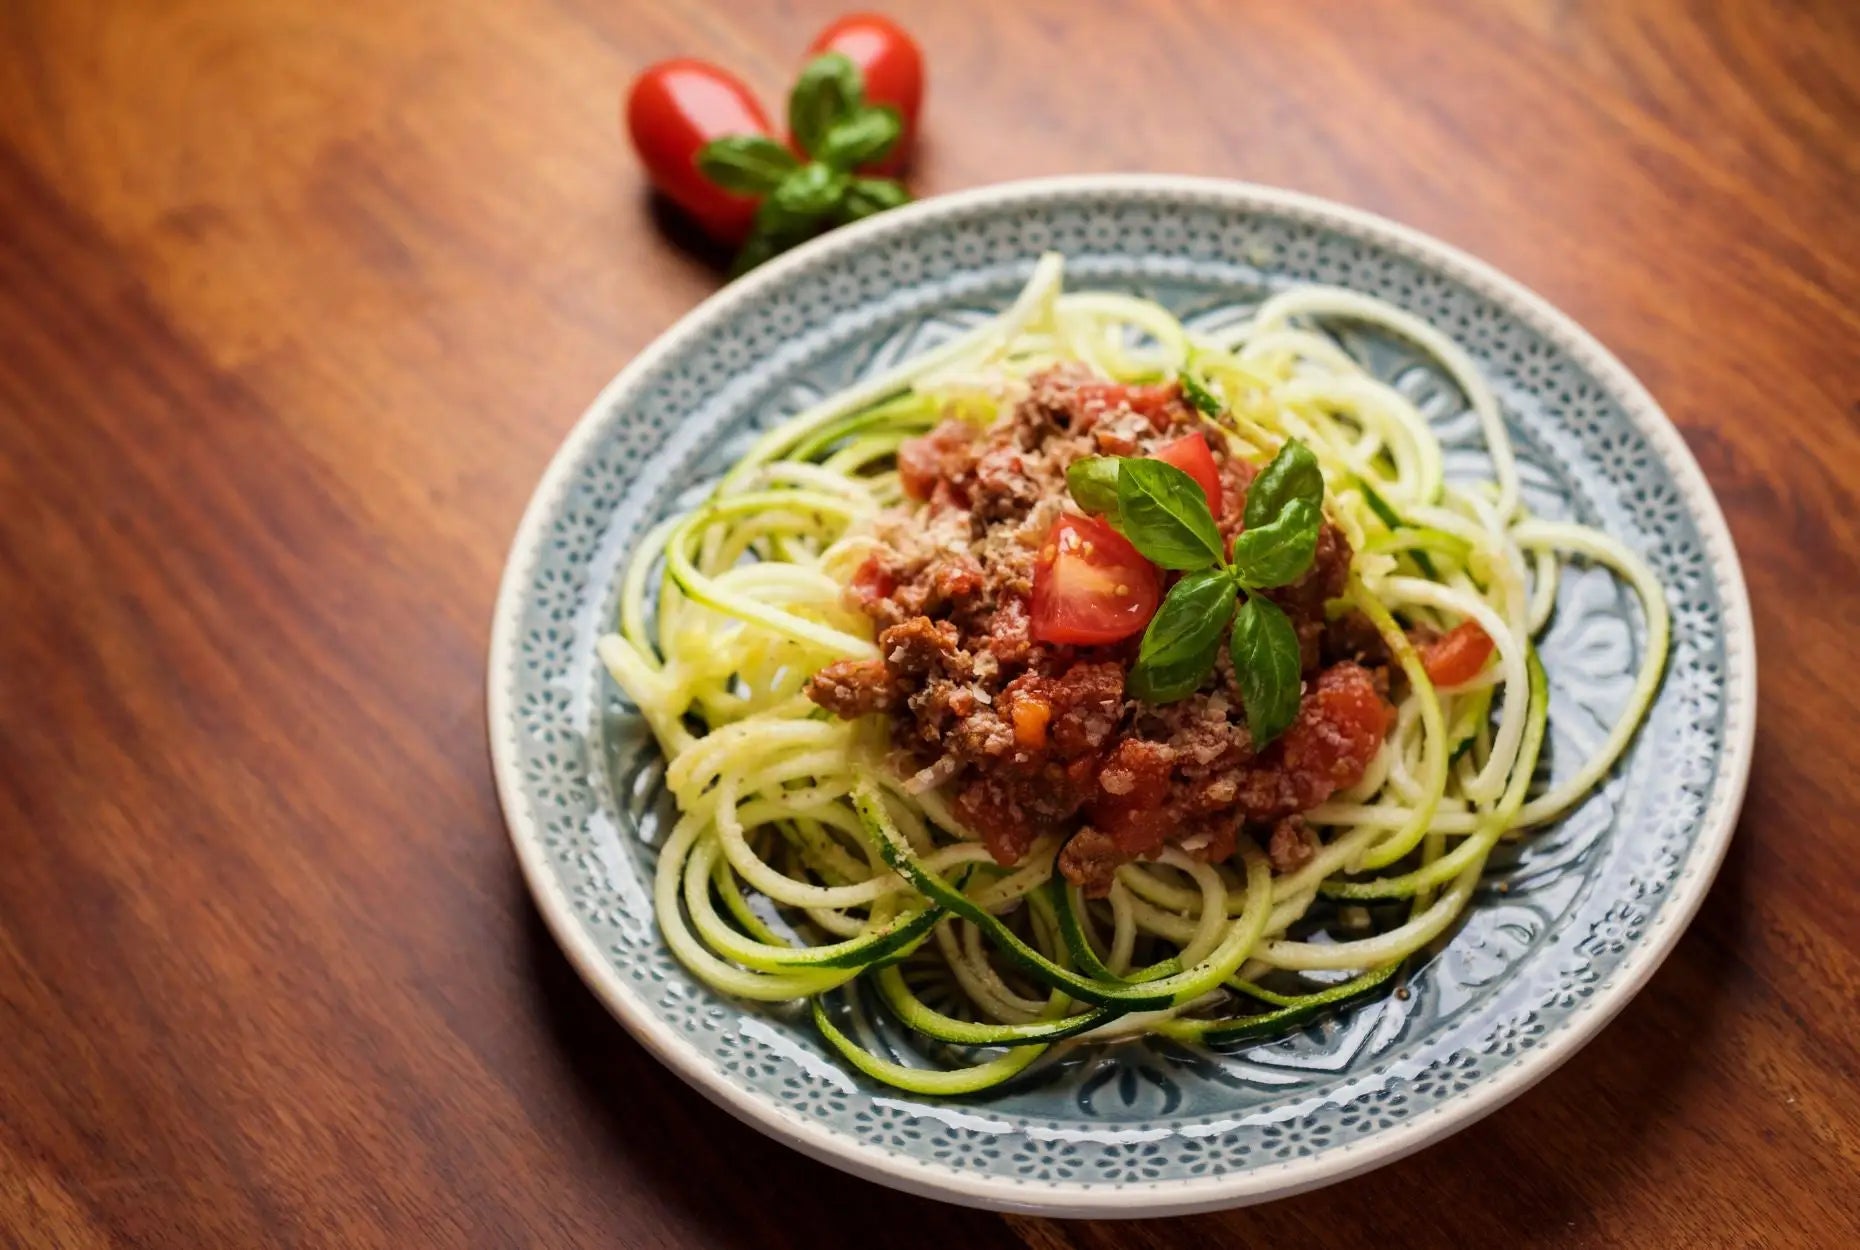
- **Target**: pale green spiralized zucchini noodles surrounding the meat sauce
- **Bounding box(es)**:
[599,255,1670,1096]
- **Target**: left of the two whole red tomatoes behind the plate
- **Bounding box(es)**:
[627,60,768,244]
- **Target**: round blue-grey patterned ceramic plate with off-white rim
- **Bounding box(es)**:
[489,177,1756,1215]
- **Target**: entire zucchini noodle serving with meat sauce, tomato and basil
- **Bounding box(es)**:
[599,257,1668,1094]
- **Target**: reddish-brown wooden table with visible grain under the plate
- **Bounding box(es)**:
[0,0,1860,1250]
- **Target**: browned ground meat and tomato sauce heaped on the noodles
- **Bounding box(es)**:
[807,366,1393,893]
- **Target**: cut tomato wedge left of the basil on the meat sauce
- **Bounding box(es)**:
[1030,517,1163,645]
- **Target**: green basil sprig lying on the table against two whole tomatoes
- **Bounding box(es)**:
[698,52,911,275]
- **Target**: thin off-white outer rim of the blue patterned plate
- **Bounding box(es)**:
[485,173,1756,1218]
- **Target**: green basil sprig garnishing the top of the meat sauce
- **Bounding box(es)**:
[1066,437,1324,746]
